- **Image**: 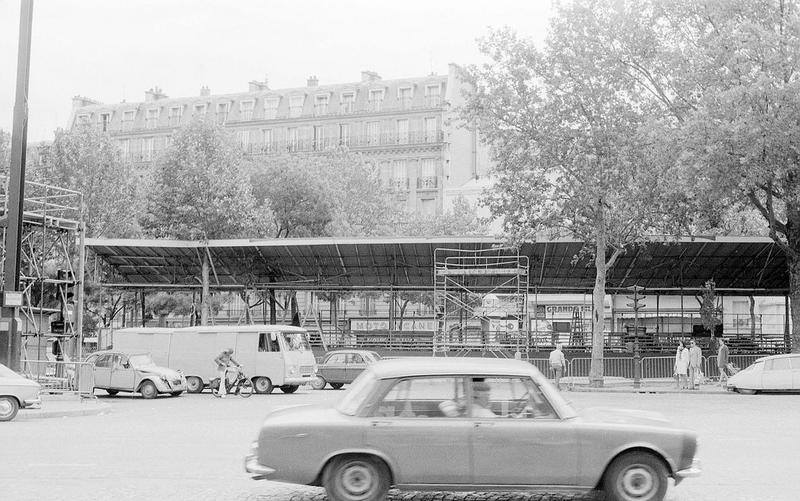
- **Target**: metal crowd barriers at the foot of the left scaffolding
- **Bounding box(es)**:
[21,360,94,396]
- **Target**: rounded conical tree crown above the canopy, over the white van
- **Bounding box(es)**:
[142,120,254,239]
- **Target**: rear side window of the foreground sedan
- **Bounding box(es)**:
[373,376,465,419]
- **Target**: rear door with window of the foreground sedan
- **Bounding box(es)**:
[366,376,472,485]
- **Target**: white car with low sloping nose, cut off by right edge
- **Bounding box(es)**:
[726,354,800,395]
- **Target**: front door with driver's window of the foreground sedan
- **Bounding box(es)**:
[471,376,578,485]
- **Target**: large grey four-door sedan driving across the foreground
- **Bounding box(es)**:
[245,358,700,501]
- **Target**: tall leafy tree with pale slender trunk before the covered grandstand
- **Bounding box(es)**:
[462,9,680,386]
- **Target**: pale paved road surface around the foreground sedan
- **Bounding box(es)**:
[0,389,800,501]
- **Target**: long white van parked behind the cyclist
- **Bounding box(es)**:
[112,325,316,393]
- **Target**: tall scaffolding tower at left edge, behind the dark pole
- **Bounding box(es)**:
[0,176,84,369]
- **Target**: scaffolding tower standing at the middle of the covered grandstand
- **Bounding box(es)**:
[433,247,530,357]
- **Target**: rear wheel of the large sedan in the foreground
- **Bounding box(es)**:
[322,456,390,501]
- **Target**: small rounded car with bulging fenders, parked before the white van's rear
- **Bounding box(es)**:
[86,351,186,398]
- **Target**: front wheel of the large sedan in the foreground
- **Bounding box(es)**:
[603,452,668,501]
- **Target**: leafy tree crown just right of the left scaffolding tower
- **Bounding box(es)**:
[26,127,141,237]
